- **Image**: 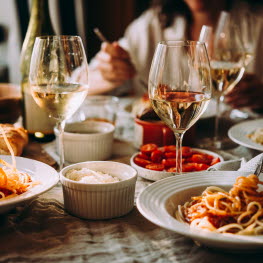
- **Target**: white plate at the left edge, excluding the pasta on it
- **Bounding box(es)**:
[0,155,59,213]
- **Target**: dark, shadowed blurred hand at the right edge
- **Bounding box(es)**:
[225,74,263,110]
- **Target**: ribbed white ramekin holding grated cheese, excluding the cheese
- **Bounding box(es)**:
[60,161,137,219]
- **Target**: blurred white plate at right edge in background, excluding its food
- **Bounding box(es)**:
[228,119,263,151]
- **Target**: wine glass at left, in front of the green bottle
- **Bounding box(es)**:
[29,36,88,169]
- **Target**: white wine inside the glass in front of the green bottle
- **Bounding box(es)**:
[31,84,87,120]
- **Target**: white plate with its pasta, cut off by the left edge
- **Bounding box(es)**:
[0,155,59,213]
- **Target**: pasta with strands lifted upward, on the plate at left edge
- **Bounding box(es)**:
[0,125,38,200]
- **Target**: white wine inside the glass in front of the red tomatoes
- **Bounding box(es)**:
[151,91,210,133]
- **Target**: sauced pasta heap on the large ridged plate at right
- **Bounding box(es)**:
[175,174,263,235]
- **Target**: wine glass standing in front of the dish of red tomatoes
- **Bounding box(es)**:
[148,41,212,173]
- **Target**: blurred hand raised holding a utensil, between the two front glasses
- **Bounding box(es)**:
[96,42,135,86]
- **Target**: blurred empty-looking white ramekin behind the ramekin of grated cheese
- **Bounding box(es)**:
[55,121,115,163]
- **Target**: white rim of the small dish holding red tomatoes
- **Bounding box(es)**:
[130,148,224,181]
